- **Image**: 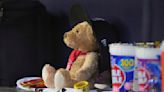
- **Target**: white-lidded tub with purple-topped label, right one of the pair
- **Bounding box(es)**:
[133,47,161,92]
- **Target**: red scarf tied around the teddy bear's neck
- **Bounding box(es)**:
[66,50,87,70]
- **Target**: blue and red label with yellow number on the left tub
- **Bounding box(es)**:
[111,55,135,92]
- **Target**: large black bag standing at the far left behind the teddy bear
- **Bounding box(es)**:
[0,1,47,86]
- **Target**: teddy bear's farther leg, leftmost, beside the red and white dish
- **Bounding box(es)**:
[42,64,56,88]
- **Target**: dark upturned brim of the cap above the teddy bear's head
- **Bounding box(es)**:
[69,3,91,27]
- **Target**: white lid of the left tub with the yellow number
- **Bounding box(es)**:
[109,43,135,56]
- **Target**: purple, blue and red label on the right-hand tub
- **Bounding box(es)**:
[137,59,161,92]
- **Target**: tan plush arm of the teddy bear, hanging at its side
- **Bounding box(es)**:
[76,52,98,81]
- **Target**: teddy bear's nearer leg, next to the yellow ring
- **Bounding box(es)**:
[54,68,77,89]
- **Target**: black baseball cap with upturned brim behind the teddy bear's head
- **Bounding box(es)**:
[69,3,119,43]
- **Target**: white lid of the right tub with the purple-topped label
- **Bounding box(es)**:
[136,47,160,59]
